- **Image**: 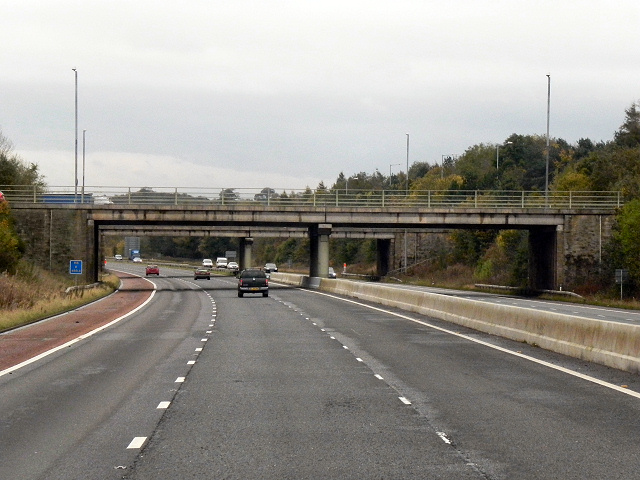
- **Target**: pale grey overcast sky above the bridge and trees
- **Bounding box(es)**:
[0,0,640,191]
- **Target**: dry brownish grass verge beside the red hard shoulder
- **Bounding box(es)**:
[0,266,119,331]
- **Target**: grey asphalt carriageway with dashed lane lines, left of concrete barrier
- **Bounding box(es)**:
[0,264,640,480]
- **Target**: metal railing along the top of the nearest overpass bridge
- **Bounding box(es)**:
[0,185,624,210]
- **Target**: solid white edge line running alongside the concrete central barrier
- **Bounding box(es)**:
[302,290,640,398]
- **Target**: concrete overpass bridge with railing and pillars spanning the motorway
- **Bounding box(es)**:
[0,186,622,289]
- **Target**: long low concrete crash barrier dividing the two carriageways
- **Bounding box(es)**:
[272,273,640,373]
